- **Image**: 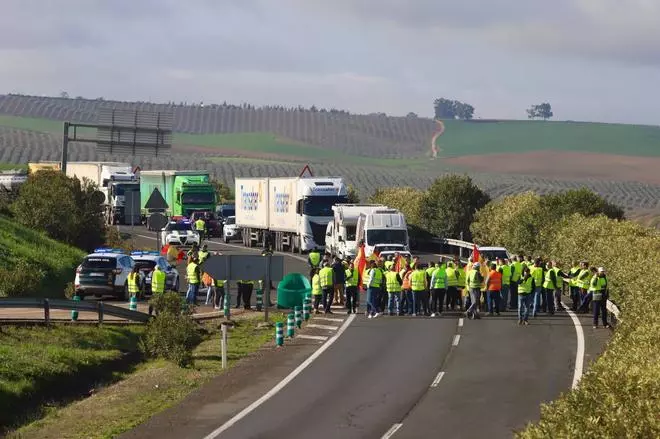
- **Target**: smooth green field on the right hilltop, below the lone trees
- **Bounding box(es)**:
[437,120,660,157]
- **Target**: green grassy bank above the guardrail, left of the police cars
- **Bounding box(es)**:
[0,215,85,298]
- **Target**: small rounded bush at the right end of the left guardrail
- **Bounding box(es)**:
[140,292,201,367]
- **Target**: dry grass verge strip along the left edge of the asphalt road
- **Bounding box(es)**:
[8,313,284,439]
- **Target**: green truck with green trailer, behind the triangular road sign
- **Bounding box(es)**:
[140,170,216,221]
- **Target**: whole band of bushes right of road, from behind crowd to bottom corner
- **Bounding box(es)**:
[472,191,660,439]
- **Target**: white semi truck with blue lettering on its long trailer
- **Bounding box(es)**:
[235,177,347,253]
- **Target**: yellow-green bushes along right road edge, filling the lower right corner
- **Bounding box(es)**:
[518,215,660,439]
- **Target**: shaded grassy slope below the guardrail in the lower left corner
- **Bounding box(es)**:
[0,325,144,431]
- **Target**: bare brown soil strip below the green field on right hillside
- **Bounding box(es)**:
[443,151,660,184]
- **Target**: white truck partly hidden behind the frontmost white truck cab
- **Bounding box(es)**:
[325,204,387,259]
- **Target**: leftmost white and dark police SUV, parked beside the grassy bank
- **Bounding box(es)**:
[73,248,141,300]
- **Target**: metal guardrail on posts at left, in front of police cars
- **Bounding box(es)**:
[0,297,151,324]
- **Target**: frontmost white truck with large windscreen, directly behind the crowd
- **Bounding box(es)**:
[356,208,410,257]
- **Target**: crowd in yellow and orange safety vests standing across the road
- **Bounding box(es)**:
[308,250,609,328]
